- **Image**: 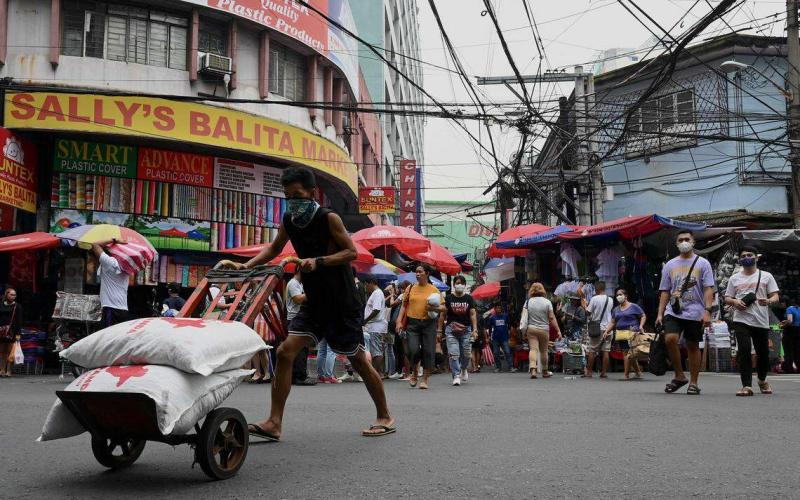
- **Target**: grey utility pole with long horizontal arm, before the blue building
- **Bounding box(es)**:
[478,66,603,226]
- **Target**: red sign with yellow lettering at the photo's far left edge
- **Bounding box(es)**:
[0,127,36,213]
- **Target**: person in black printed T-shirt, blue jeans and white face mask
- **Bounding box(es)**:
[438,276,478,386]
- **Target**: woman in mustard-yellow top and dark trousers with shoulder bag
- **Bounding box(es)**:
[395,264,446,389]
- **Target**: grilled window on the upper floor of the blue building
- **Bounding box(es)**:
[625,89,697,157]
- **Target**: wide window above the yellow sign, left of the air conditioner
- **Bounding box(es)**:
[61,0,189,70]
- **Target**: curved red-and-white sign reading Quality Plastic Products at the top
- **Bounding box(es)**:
[200,0,359,100]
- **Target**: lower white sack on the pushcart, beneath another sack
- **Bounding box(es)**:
[37,365,253,441]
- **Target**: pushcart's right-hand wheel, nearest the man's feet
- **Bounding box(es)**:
[195,408,249,479]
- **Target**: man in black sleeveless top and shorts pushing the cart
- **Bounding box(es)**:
[231,168,395,441]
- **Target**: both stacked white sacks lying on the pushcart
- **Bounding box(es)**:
[38,318,265,441]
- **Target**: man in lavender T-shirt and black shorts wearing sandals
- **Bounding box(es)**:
[656,231,716,395]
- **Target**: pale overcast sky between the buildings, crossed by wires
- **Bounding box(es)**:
[417,0,786,207]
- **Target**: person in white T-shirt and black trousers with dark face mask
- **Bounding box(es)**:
[725,247,780,396]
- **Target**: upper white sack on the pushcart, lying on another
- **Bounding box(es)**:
[61,318,266,375]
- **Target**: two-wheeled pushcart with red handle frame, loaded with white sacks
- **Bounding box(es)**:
[56,261,294,479]
